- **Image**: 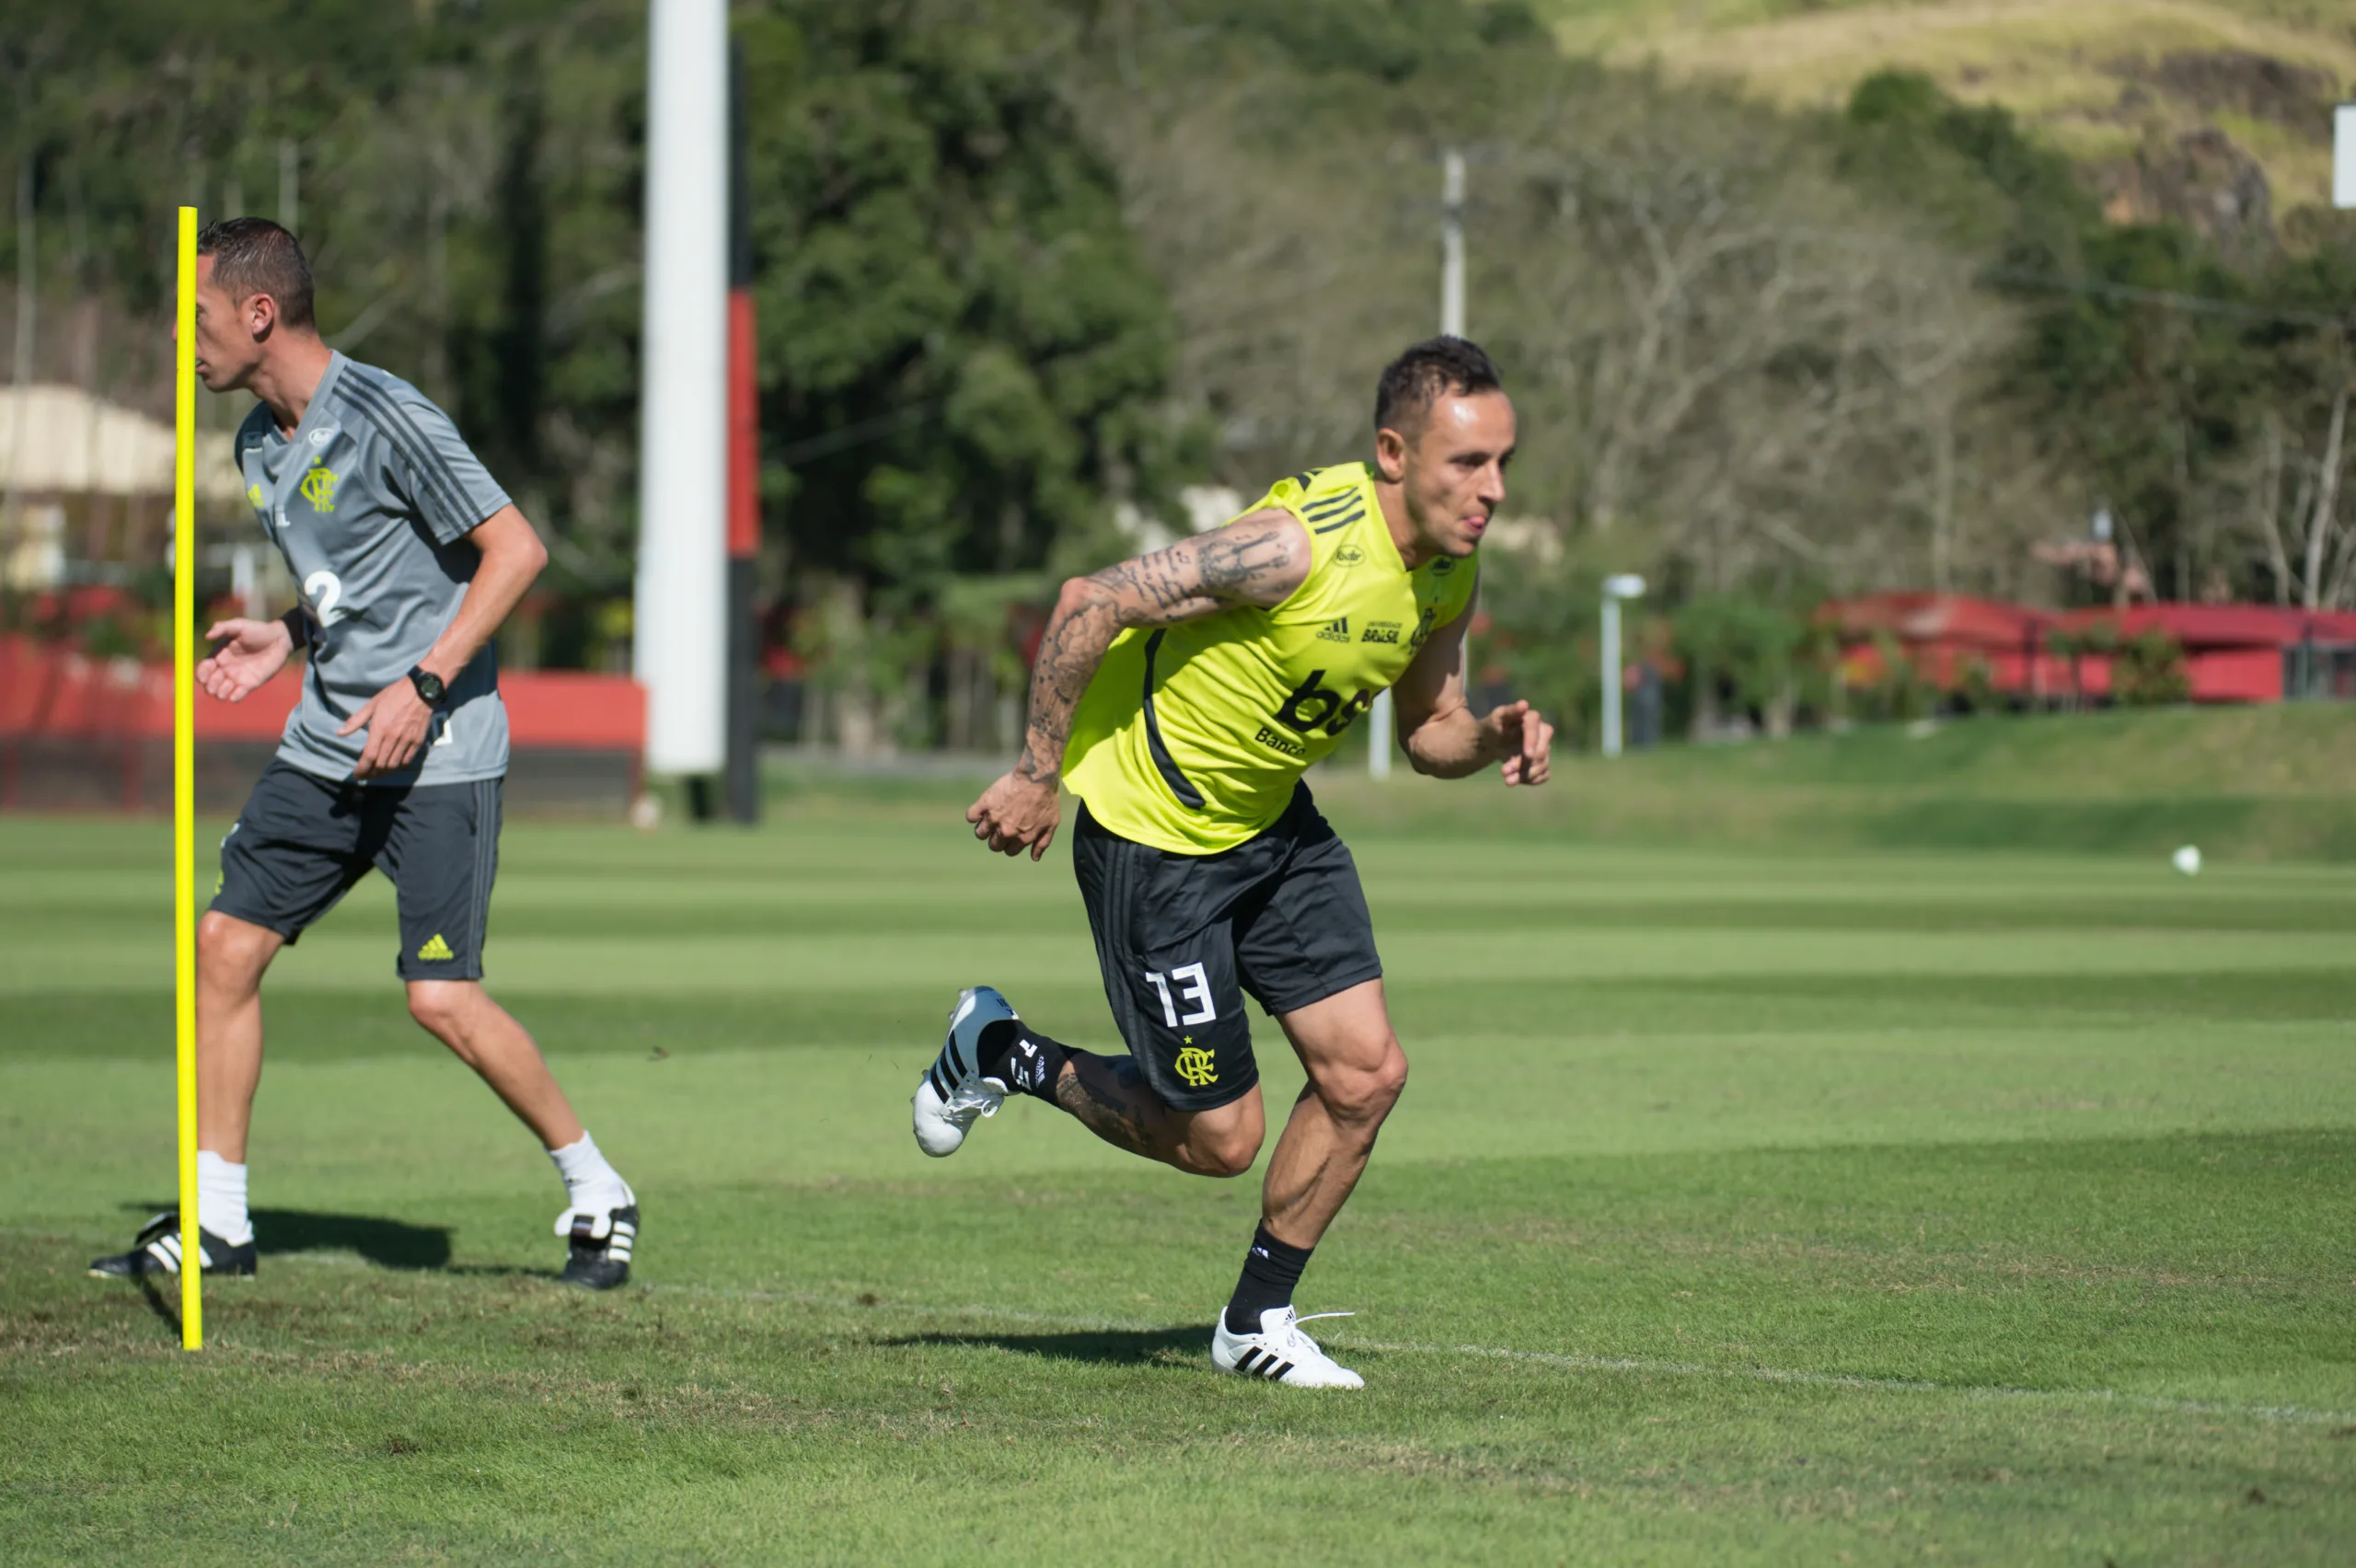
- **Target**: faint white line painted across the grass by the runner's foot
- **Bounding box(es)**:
[641,1286,2356,1424]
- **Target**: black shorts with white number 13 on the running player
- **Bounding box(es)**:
[1072,784,1383,1112]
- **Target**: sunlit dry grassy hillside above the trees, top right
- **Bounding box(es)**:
[1539,0,2356,219]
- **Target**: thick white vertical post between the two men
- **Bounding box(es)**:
[634,0,728,775]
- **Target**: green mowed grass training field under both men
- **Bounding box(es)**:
[0,784,2356,1568]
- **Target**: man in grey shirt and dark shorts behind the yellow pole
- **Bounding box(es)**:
[89,219,639,1290]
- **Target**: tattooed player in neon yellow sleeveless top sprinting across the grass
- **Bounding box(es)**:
[912,337,1555,1389]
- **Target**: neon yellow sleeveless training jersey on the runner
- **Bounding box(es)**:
[1063,464,1475,855]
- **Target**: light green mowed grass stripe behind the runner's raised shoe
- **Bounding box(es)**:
[18,1027,2356,1200]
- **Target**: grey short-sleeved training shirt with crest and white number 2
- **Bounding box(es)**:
[238,353,506,784]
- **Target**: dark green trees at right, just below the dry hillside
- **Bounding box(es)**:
[1842,71,2356,603]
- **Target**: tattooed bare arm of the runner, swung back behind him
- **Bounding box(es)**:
[966,506,1310,859]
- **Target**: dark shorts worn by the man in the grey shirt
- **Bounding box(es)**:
[212,760,500,979]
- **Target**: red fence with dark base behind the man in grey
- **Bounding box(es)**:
[0,636,645,813]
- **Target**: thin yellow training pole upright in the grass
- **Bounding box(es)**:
[172,207,205,1349]
